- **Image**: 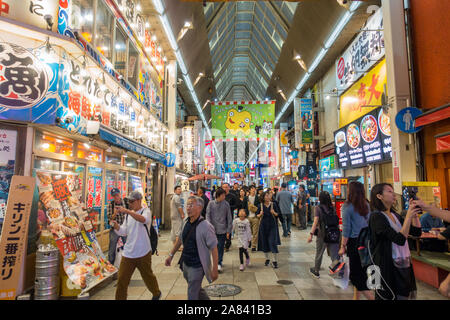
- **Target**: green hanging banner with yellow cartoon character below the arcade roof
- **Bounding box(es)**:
[211,100,275,139]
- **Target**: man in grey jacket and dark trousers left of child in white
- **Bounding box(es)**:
[206,188,233,272]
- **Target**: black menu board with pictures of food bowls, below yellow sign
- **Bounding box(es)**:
[334,108,392,169]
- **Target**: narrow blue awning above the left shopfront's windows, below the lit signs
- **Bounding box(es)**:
[98,126,165,163]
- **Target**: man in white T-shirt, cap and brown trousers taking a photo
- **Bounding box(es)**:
[110,191,161,300]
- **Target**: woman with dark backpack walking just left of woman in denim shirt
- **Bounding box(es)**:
[307,191,339,279]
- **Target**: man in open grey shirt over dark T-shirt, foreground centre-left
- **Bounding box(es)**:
[165,196,219,300]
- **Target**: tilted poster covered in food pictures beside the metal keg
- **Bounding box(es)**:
[36,170,117,293]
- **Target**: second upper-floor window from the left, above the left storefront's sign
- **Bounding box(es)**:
[95,0,114,60]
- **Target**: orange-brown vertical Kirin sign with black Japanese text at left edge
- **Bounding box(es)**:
[0,176,36,300]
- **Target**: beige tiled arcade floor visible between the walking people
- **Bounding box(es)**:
[90,227,446,300]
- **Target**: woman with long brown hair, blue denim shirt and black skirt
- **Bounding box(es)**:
[339,181,374,300]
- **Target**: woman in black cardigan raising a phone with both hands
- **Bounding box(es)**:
[369,183,422,300]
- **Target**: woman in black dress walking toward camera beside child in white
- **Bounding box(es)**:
[256,191,281,269]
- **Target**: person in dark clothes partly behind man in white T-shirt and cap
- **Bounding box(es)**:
[107,188,128,264]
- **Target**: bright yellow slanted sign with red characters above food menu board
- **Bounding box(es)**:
[339,59,387,128]
